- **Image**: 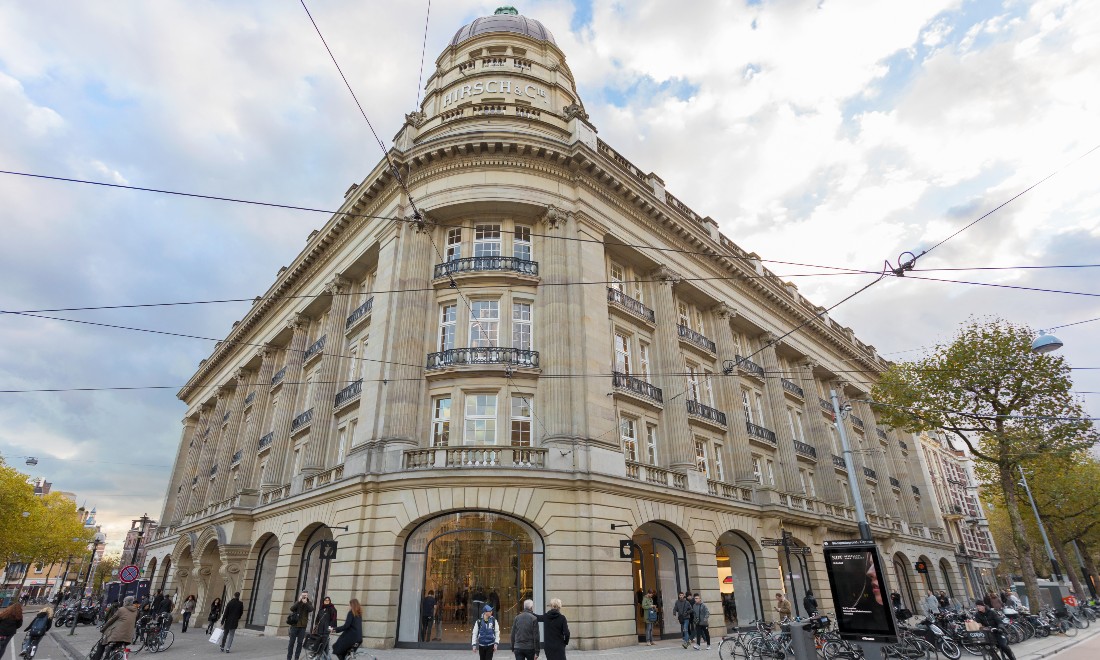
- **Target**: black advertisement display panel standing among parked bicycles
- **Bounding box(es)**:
[824,541,897,638]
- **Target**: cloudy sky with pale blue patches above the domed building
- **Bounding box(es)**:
[0,0,1100,554]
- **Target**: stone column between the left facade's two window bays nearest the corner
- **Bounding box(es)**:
[301,275,351,471]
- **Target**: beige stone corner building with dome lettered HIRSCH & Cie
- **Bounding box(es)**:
[149,13,960,648]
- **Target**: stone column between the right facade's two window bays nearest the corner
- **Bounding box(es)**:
[650,266,690,470]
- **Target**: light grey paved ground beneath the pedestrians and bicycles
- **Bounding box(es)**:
[25,625,1100,660]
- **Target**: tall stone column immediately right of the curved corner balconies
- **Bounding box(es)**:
[535,206,584,444]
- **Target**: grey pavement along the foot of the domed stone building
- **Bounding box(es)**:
[35,624,1100,660]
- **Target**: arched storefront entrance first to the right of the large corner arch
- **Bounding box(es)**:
[630,523,691,639]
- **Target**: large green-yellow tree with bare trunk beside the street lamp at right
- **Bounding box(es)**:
[872,319,1097,602]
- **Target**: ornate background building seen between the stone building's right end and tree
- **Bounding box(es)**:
[920,432,1003,602]
